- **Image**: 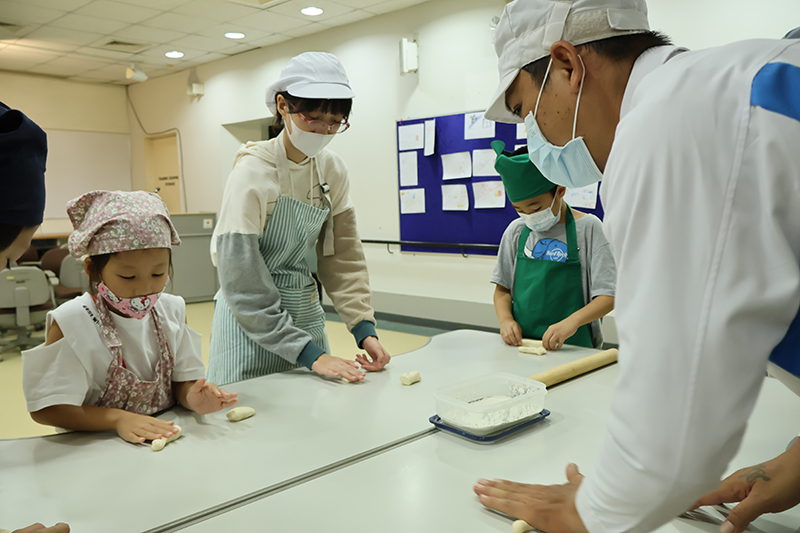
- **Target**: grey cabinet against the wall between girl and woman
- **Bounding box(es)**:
[169,213,219,303]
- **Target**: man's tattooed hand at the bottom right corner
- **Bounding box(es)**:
[692,441,800,533]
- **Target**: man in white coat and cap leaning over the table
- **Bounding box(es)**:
[475,0,800,533]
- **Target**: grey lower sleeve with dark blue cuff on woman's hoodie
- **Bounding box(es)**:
[217,233,324,368]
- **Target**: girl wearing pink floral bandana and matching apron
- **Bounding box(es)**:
[23,191,237,443]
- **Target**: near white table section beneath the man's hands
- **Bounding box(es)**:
[178,366,800,533]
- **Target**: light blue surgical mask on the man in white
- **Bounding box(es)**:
[525,56,603,189]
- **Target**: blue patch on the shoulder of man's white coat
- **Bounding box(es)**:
[750,63,800,121]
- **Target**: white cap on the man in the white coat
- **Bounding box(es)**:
[485,0,650,122]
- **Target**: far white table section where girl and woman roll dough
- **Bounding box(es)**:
[0,330,610,533]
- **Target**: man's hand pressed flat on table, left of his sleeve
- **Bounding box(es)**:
[473,464,587,533]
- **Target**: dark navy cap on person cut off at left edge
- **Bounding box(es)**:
[0,102,47,227]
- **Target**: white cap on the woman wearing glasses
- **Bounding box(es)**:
[267,52,355,115]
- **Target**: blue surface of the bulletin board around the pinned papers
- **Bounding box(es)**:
[397,113,603,255]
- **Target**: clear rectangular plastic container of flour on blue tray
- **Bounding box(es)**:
[434,373,547,435]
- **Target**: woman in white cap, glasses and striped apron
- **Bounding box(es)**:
[208,52,390,383]
